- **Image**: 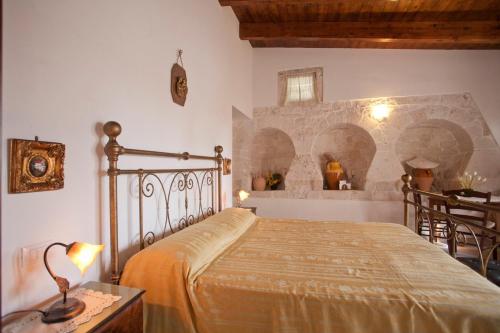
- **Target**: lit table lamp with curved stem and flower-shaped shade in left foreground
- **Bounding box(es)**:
[42,242,104,323]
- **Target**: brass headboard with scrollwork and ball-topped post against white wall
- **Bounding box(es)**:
[104,121,224,283]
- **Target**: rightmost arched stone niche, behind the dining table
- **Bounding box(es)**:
[395,119,474,191]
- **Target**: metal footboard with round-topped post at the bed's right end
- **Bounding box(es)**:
[401,175,500,276]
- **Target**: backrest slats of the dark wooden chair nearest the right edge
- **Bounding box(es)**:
[443,189,491,226]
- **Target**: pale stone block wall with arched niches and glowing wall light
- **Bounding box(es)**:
[233,93,500,200]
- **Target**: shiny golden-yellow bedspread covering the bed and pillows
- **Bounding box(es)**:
[121,209,500,333]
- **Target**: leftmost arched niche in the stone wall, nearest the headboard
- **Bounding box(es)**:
[251,128,295,189]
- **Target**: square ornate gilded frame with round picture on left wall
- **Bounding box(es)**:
[9,139,65,193]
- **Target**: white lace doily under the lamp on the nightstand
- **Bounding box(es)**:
[2,288,122,333]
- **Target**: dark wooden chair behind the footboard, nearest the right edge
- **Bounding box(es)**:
[443,189,495,252]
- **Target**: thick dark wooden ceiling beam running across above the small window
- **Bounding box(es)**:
[240,21,500,44]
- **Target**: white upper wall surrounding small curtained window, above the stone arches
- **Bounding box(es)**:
[253,49,500,142]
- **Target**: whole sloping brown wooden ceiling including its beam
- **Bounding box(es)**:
[219,0,500,49]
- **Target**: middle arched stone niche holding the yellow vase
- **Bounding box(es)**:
[312,123,377,190]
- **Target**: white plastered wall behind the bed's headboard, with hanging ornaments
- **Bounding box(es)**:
[1,0,252,313]
